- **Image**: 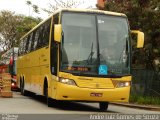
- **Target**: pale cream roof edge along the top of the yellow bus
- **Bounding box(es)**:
[20,8,126,39]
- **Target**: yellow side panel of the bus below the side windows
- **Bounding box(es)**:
[17,47,50,95]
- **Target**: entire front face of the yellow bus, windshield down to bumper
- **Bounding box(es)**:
[52,11,131,102]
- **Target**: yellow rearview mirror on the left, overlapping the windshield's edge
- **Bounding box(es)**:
[54,24,62,43]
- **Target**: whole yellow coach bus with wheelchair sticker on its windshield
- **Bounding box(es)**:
[17,9,144,110]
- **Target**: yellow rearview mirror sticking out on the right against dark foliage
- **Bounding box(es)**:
[131,30,144,48]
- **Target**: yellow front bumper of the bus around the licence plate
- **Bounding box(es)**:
[54,83,130,102]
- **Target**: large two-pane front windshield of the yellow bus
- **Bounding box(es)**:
[60,12,130,76]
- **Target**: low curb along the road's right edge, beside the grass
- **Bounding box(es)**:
[110,102,160,111]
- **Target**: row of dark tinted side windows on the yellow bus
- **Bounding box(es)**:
[19,19,51,55]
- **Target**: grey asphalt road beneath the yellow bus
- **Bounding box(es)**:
[0,92,160,120]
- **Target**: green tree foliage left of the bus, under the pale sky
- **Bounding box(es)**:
[0,11,41,51]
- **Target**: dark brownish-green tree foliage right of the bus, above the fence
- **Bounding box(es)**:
[105,0,160,68]
